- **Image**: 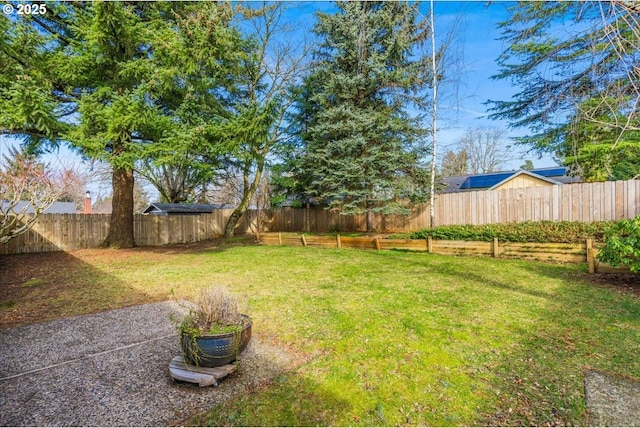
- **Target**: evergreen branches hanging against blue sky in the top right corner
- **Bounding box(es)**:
[491,1,640,179]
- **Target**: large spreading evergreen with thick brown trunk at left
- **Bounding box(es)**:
[0,2,244,247]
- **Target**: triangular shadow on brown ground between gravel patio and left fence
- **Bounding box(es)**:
[0,250,155,329]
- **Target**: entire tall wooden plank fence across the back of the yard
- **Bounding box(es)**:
[0,180,640,254]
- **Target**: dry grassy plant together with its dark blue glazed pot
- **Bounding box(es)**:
[178,286,252,367]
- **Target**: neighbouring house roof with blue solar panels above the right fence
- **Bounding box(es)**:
[442,166,579,193]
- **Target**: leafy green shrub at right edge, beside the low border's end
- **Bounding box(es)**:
[598,215,640,272]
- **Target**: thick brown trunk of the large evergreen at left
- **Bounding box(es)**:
[103,168,135,248]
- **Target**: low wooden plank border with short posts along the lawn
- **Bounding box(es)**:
[258,233,629,273]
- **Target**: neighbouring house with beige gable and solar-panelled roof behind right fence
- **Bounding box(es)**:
[440,166,579,193]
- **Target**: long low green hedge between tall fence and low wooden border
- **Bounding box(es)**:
[410,220,614,243]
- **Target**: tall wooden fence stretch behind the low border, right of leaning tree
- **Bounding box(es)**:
[262,180,640,233]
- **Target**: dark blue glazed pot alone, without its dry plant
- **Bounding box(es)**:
[181,315,252,367]
